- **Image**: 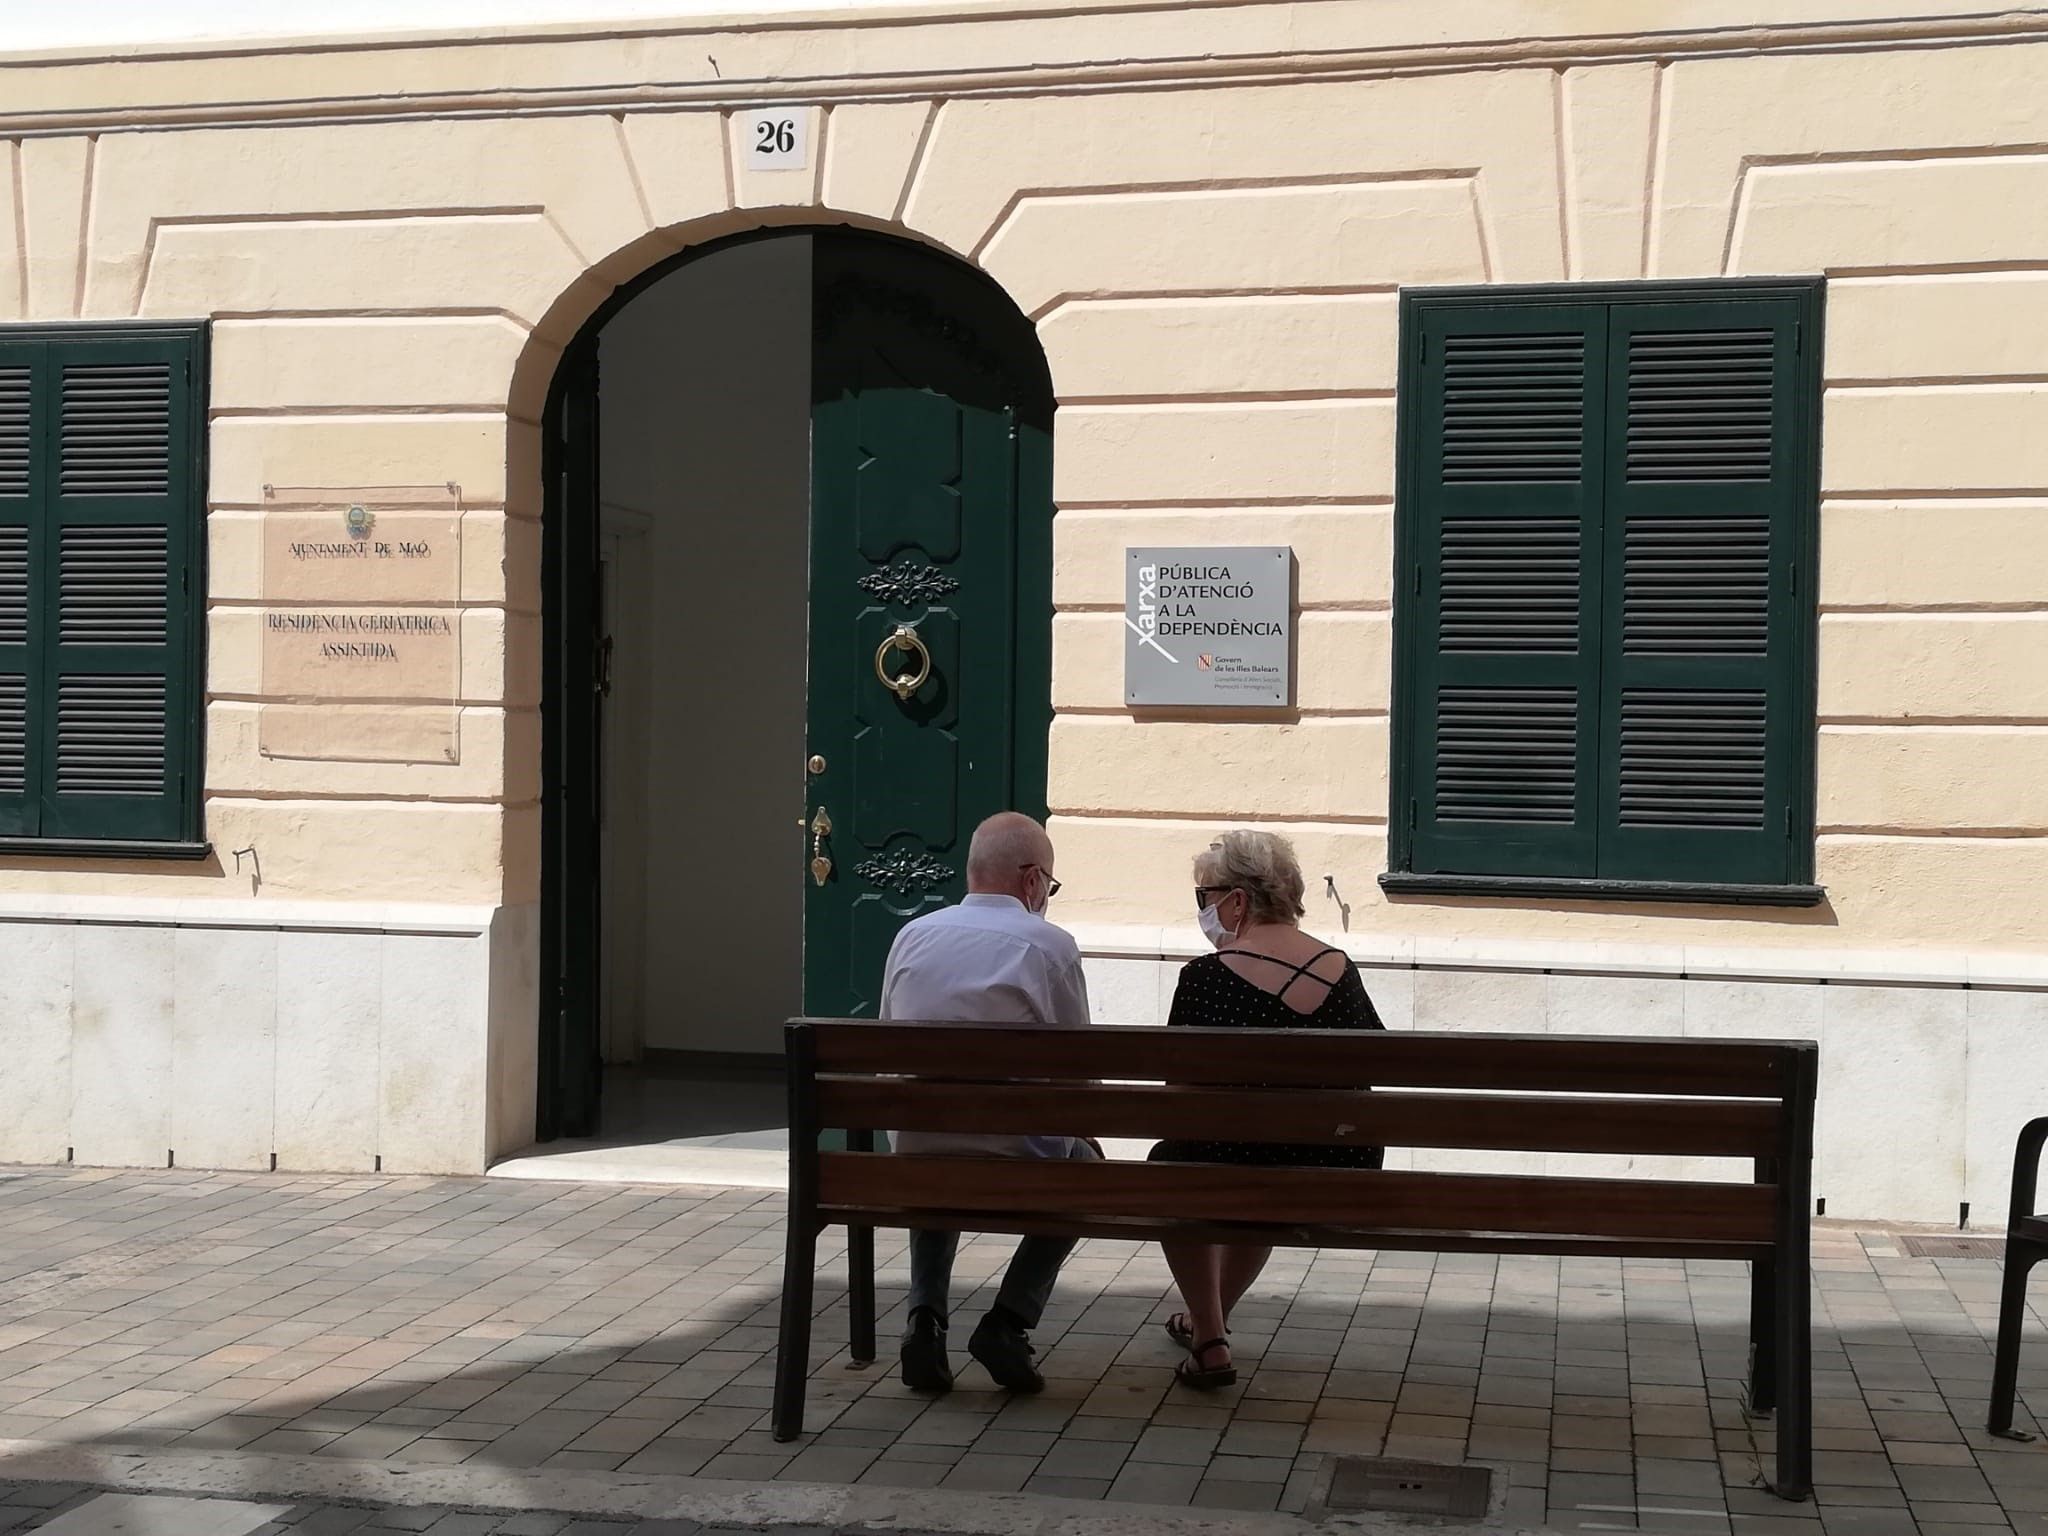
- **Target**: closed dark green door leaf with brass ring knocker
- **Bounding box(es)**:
[791,233,1053,1018]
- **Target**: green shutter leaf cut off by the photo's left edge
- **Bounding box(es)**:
[0,342,41,838]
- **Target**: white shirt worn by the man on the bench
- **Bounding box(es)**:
[881,895,1087,1157]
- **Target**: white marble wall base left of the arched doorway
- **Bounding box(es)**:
[0,903,537,1174]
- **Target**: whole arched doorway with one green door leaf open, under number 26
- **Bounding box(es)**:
[539,227,1053,1141]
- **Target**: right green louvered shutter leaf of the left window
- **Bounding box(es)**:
[29,334,201,842]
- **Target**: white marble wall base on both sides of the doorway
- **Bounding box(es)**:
[0,899,2048,1225]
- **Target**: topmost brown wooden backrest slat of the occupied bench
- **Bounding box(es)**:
[811,1020,1815,1098]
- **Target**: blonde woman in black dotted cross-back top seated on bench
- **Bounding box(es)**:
[1151,831,1384,1391]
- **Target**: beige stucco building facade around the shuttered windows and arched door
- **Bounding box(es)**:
[0,0,2048,1219]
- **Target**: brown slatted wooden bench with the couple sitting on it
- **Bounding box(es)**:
[774,1020,1819,1499]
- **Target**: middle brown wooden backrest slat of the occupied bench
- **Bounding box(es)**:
[817,1075,1780,1157]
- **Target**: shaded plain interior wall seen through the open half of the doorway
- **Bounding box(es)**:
[598,236,811,1061]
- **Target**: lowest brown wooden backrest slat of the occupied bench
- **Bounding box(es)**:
[817,1153,1778,1243]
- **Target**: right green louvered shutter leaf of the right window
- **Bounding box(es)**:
[1599,299,1806,885]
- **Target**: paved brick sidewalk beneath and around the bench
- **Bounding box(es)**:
[0,1169,2048,1536]
